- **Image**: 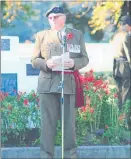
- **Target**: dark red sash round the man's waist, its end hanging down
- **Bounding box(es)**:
[55,70,84,108]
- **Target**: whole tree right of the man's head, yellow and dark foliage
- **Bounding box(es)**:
[63,0,131,41]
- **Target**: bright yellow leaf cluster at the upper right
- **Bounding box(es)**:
[88,1,124,34]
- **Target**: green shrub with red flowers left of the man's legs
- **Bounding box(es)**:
[1,91,40,143]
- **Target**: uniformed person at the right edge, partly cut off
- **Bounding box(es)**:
[112,16,131,110]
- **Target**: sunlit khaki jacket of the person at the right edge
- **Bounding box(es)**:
[112,31,131,77]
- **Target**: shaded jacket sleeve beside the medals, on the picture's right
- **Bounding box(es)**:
[73,33,89,70]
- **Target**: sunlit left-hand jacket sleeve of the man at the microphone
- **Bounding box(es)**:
[31,33,51,72]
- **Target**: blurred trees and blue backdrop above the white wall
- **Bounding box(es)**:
[1,0,131,43]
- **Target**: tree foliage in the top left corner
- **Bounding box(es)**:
[0,0,35,28]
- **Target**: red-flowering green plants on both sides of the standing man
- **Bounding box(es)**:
[1,70,131,146]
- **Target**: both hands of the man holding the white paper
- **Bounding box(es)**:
[46,58,75,69]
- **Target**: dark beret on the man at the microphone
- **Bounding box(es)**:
[45,6,65,17]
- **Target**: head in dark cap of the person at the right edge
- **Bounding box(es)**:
[120,16,131,31]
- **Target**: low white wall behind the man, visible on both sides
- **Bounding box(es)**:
[1,36,113,92]
